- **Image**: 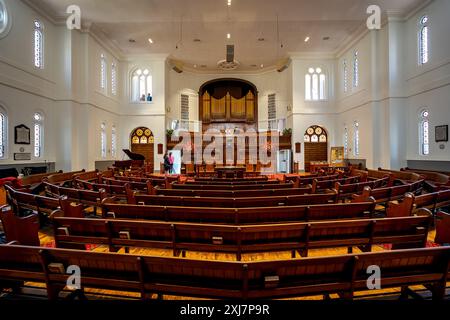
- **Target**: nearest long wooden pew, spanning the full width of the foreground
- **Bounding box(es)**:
[0,245,450,300]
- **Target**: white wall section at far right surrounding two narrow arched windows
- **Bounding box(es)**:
[404,0,450,161]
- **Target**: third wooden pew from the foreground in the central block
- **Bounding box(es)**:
[102,199,375,225]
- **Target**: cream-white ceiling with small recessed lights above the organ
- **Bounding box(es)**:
[29,0,423,70]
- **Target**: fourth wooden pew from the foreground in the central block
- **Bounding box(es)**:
[128,192,336,208]
